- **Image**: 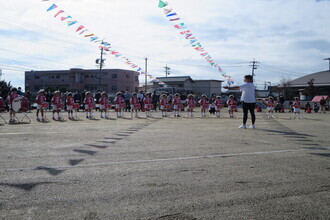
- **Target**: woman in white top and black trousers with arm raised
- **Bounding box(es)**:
[224,75,256,129]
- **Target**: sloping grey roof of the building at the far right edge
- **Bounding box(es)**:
[291,71,330,87]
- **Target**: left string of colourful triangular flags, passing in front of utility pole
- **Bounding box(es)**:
[42,0,152,78]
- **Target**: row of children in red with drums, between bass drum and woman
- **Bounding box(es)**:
[32,90,240,121]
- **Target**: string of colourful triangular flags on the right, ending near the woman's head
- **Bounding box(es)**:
[158,0,235,84]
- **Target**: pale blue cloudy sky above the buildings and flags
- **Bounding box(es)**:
[0,0,330,88]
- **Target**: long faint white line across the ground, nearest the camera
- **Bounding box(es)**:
[0,147,330,172]
